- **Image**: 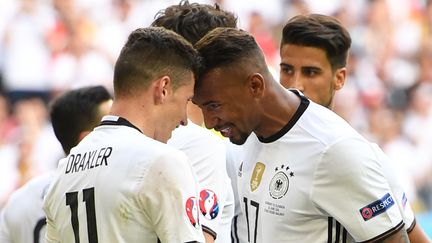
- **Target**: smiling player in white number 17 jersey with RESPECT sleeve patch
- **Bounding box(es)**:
[193,28,408,243]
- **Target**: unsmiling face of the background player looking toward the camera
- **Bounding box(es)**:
[280,44,346,108]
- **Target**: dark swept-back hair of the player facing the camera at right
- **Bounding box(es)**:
[281,14,351,70]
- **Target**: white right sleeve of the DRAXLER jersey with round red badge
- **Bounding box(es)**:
[139,150,204,243]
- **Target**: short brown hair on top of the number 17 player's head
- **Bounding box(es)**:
[195,28,268,85]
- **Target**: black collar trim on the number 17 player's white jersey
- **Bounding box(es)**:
[258,89,310,143]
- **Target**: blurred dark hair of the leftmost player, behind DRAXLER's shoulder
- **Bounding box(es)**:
[50,86,111,154]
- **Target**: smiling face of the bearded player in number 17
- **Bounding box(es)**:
[193,68,259,144]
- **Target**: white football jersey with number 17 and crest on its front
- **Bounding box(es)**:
[238,91,404,243]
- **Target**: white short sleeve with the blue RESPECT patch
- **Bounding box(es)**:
[310,138,404,242]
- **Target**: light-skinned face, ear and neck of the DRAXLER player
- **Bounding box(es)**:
[110,72,194,143]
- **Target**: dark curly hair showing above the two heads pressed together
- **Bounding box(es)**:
[152,0,237,44]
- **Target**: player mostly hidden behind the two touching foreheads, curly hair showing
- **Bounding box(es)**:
[152,1,237,243]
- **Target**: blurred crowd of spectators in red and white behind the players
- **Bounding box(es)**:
[0,0,432,232]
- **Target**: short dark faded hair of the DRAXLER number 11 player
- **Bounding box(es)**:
[114,27,199,97]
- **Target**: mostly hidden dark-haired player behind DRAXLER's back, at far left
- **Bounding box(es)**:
[0,86,112,243]
